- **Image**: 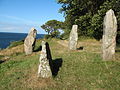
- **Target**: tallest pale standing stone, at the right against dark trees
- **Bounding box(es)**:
[102,9,117,60]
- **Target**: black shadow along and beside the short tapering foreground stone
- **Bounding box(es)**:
[46,42,63,77]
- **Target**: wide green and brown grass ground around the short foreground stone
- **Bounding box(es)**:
[0,40,120,90]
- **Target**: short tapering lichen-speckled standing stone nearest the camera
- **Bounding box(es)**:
[38,41,52,78]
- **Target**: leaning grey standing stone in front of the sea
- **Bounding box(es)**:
[24,28,37,55]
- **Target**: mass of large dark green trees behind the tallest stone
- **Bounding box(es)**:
[57,0,120,42]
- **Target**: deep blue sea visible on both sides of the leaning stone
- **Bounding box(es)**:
[0,32,44,49]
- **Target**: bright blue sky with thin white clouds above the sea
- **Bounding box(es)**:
[0,0,64,34]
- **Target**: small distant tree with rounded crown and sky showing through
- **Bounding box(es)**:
[41,20,63,37]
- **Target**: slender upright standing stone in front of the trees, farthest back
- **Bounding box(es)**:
[69,25,78,50]
